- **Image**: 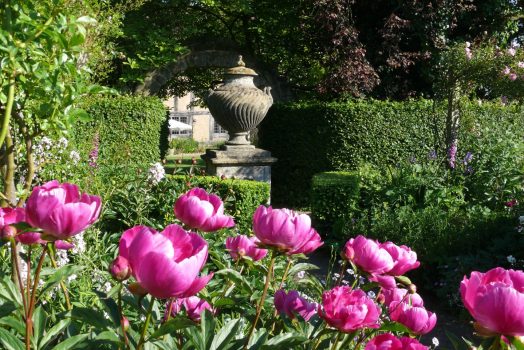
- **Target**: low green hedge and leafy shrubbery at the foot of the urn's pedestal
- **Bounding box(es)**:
[100,169,269,233]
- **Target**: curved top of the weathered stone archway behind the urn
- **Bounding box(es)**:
[135,49,292,101]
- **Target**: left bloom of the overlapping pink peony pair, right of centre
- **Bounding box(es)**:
[343,235,395,274]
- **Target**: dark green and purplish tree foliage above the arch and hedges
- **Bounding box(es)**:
[102,0,522,99]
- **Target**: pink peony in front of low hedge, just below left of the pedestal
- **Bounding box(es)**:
[174,187,235,232]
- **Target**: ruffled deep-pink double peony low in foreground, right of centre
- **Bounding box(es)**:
[318,286,380,333]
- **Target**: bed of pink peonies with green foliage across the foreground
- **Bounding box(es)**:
[0,181,524,350]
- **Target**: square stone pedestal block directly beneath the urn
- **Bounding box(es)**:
[201,145,277,183]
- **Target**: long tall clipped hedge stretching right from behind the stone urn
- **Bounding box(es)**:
[258,100,522,207]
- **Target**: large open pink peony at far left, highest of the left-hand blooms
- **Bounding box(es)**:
[25,180,100,239]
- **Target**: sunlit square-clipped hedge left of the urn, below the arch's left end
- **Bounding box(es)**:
[73,96,167,166]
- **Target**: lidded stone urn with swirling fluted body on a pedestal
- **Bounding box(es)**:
[205,56,273,146]
